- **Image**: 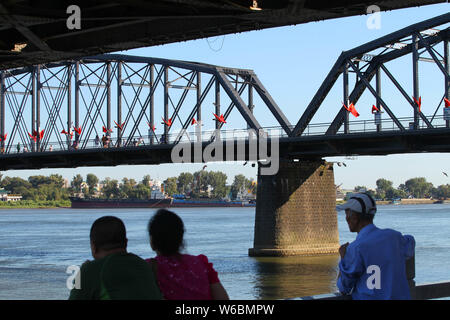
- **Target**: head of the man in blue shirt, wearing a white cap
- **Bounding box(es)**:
[336,193,377,232]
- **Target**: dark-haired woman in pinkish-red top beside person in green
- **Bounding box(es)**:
[147,209,229,300]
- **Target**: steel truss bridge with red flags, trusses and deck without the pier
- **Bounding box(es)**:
[0,13,450,170]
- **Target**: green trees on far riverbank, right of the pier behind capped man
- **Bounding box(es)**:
[354,177,450,200]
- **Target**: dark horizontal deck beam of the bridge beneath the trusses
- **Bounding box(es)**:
[0,128,450,170]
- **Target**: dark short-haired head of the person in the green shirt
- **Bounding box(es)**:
[90,216,128,259]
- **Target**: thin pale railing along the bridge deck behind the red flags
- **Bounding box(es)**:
[2,115,447,154]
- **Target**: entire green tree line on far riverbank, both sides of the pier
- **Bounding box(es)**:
[0,170,450,207]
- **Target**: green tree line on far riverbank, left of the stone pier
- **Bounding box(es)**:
[0,170,256,207]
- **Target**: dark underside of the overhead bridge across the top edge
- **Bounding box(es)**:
[0,0,446,70]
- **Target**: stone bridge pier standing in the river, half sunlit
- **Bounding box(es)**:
[249,159,339,256]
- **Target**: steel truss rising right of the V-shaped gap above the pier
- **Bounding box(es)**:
[291,13,450,137]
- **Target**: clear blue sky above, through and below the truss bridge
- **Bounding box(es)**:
[2,4,450,188]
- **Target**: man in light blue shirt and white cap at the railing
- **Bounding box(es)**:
[336,193,415,300]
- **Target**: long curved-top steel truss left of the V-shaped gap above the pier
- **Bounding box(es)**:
[0,54,292,153]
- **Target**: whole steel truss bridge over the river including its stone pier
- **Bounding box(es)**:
[0,13,450,256]
